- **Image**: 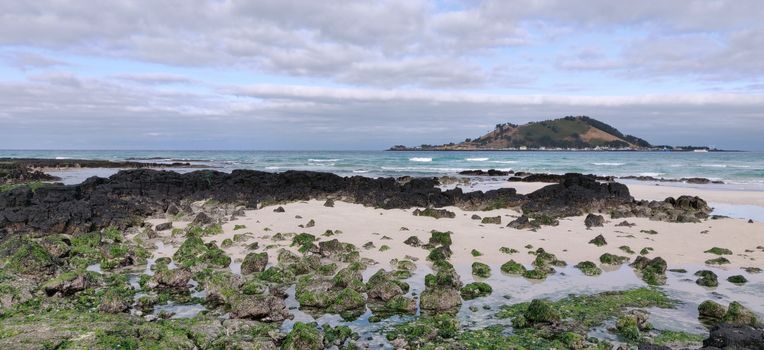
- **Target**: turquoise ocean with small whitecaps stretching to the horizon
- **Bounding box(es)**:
[0,150,764,190]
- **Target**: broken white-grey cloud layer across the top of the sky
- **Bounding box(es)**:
[0,0,764,88]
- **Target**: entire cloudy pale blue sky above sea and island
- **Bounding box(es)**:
[0,0,764,150]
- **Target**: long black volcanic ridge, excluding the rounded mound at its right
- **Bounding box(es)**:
[0,169,525,237]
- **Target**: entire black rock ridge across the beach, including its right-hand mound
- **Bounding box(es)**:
[0,169,710,237]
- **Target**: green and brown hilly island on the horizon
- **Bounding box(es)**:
[391,116,652,151]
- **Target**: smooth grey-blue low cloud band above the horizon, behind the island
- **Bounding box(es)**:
[0,73,764,149]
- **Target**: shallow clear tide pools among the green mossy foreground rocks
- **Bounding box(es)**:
[115,235,764,349]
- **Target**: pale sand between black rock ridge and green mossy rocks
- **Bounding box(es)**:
[152,197,764,269]
